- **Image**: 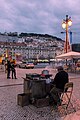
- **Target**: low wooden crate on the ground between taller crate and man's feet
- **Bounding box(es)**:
[34,98,49,107]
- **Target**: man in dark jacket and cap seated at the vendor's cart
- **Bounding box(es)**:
[49,66,69,105]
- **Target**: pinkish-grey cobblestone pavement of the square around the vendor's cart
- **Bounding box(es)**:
[0,68,80,120]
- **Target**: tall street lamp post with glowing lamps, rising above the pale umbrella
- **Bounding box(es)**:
[62,15,72,53]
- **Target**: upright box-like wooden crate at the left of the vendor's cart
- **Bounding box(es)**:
[17,93,31,107]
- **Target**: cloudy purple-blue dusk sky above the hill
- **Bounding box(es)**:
[0,0,80,43]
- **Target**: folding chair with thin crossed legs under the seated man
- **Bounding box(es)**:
[58,82,76,114]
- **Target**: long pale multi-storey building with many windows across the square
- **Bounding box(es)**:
[0,42,62,59]
